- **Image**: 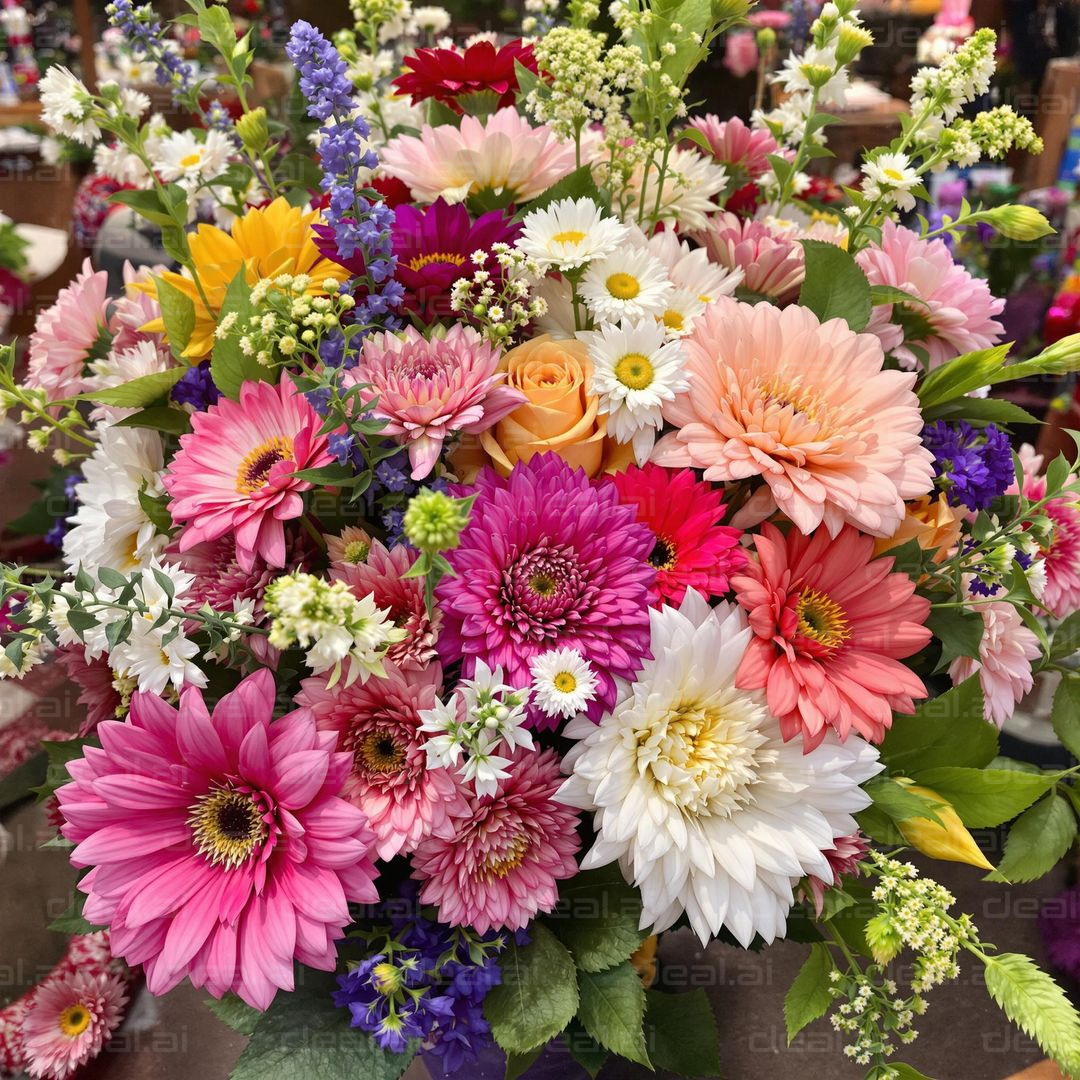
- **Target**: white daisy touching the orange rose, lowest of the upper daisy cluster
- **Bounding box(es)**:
[578,321,690,464]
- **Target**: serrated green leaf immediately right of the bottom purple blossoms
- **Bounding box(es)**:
[484,923,578,1054]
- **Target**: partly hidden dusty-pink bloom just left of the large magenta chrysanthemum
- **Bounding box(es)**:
[330,540,443,667]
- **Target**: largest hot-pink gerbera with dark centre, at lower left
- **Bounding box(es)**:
[57,669,377,1009]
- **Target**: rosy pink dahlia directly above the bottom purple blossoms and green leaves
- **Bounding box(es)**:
[413,747,580,934]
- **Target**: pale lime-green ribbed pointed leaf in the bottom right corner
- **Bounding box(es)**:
[985,953,1080,1074]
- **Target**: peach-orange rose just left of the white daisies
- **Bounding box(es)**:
[453,334,633,483]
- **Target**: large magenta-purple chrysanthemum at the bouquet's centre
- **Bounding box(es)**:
[437,454,656,727]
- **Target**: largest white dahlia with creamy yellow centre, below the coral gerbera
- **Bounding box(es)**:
[557,589,881,946]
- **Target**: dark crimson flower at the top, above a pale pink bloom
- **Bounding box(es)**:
[394,39,537,113]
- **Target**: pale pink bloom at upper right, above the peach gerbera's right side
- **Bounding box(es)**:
[855,221,1005,367]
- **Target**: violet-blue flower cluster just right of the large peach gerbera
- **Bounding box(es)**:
[922,420,1015,510]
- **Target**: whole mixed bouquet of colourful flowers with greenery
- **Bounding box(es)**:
[0,0,1080,1080]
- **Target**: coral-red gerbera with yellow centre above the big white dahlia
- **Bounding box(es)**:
[731,524,931,751]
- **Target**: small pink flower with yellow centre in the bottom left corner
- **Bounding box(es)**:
[22,971,127,1080]
